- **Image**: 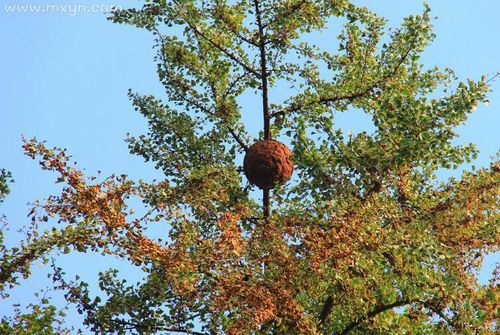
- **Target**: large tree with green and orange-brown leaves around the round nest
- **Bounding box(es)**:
[0,0,500,335]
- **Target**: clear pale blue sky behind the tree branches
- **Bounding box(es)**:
[0,0,500,325]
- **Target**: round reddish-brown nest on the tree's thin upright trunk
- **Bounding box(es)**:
[243,140,293,190]
